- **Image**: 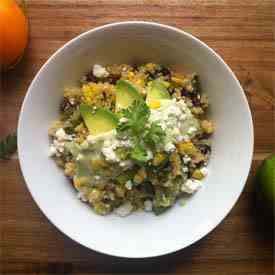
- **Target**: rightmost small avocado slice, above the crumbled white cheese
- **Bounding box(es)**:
[146,79,171,103]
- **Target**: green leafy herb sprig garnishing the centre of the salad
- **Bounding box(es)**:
[117,100,165,164]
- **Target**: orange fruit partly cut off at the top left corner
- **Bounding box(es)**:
[0,0,28,70]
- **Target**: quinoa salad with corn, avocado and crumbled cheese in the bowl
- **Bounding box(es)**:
[48,63,214,216]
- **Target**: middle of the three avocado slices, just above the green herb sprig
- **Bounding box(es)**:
[116,80,143,111]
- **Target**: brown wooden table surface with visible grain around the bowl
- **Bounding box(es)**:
[0,0,275,275]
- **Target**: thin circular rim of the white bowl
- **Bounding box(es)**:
[17,21,254,259]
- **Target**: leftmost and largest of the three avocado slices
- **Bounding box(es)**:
[79,104,119,136]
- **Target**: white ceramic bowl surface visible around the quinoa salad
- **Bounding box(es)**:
[18,22,253,258]
